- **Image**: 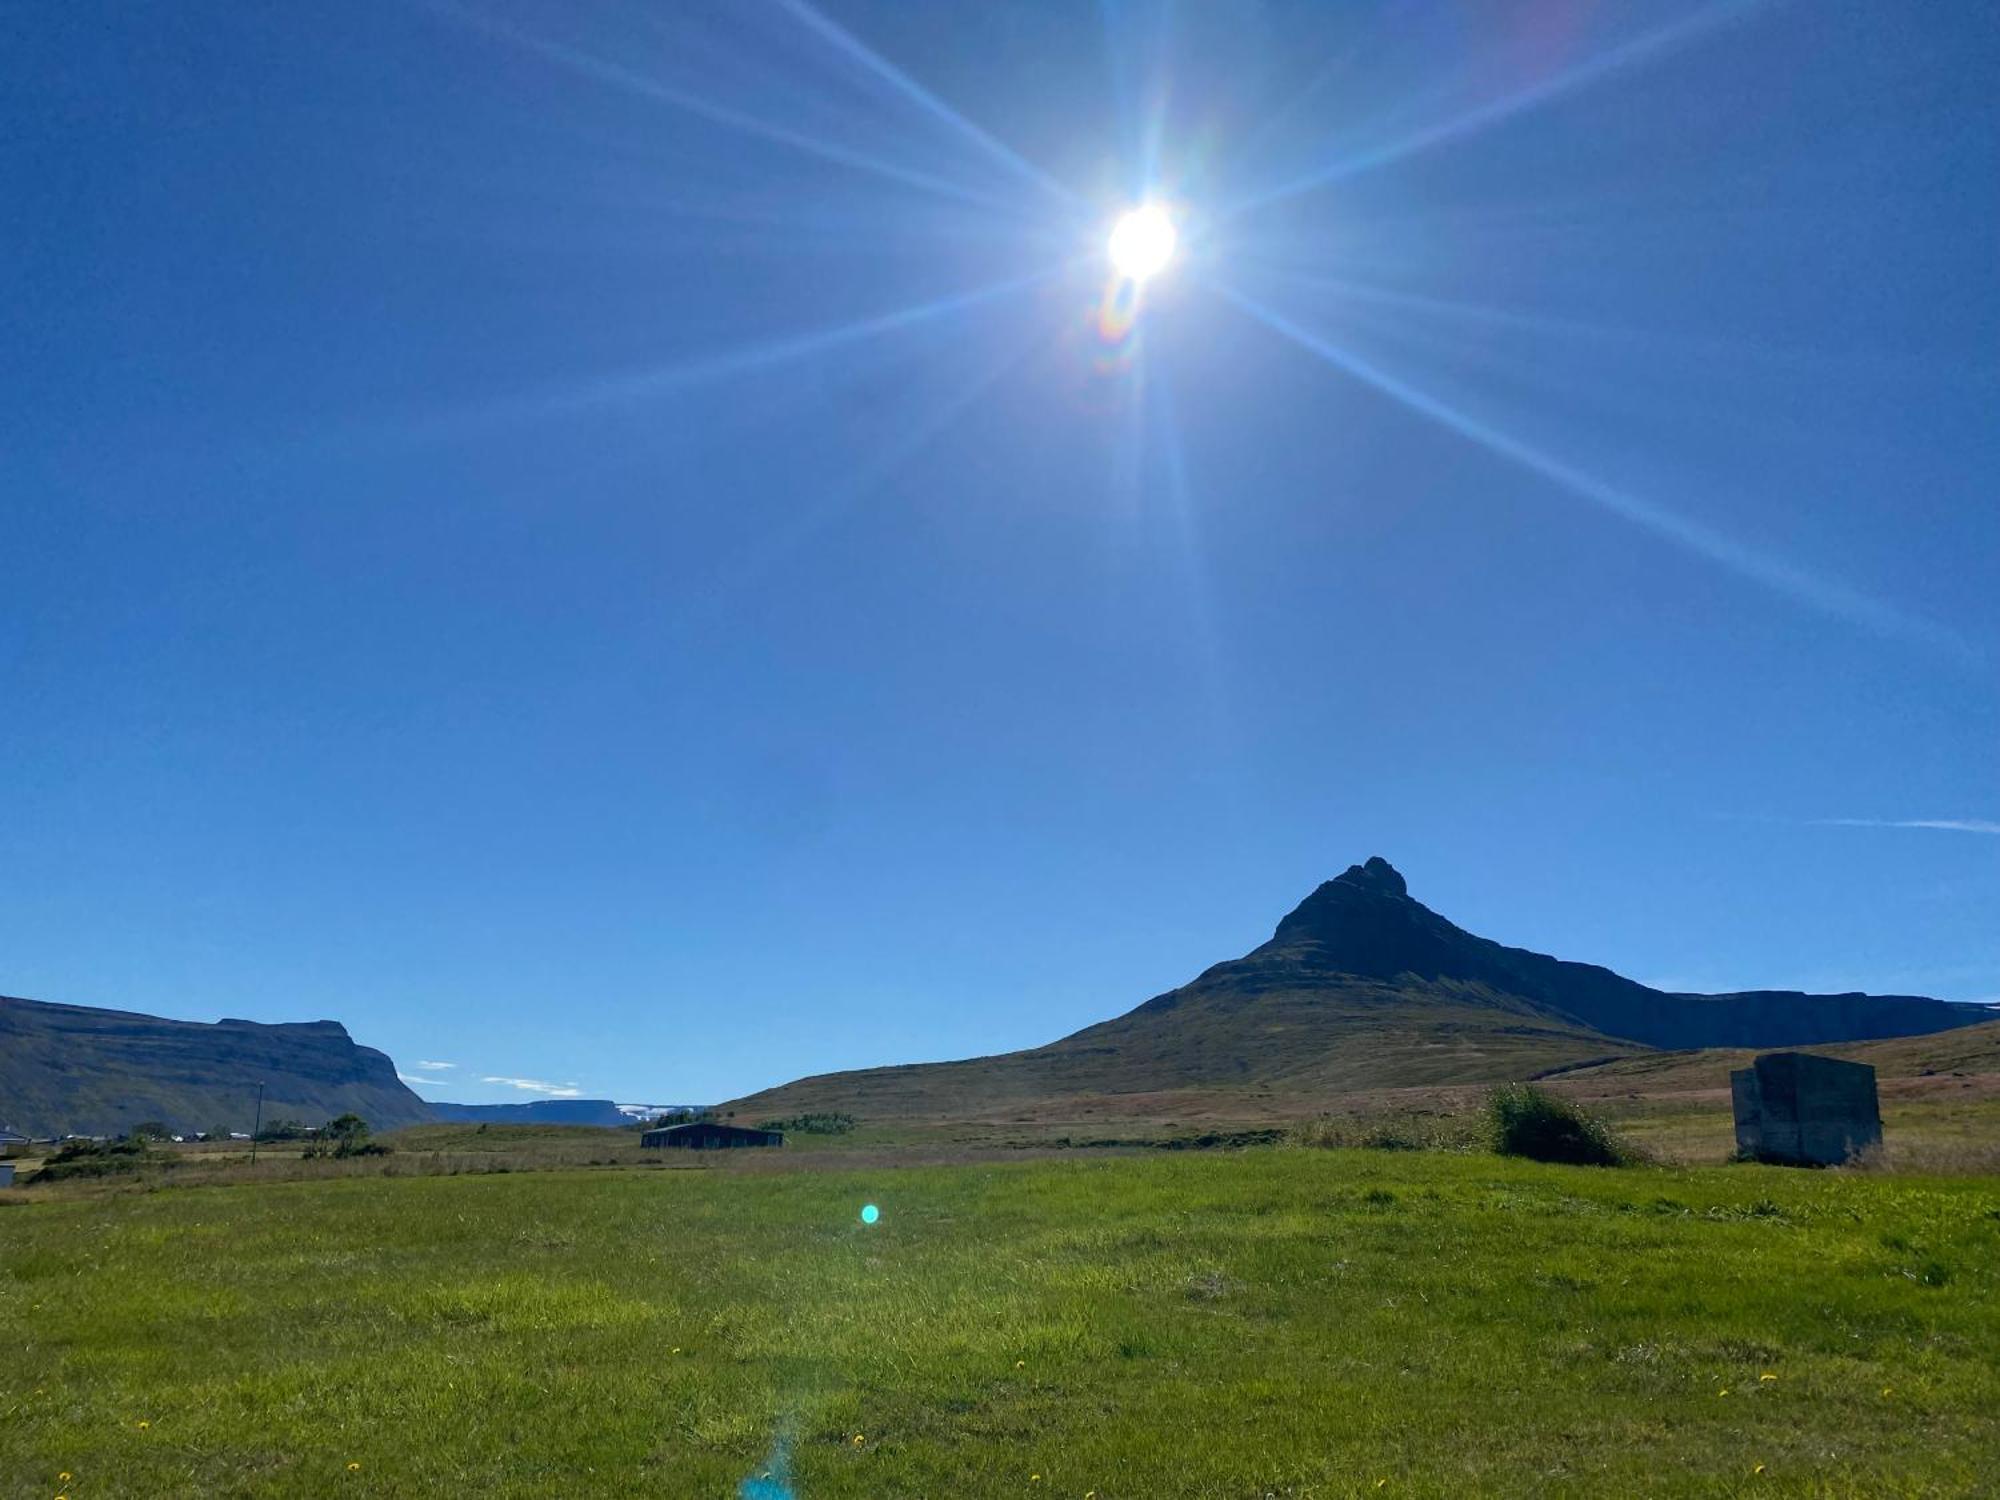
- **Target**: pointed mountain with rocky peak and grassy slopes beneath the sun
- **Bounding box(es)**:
[732,860,1990,1120]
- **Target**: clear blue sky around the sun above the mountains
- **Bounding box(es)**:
[0,0,2000,1100]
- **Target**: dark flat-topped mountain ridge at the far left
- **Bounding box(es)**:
[0,996,432,1136]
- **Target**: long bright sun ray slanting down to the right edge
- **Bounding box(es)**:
[1216,284,1976,658]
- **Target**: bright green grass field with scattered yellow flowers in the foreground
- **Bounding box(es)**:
[0,1148,2000,1500]
